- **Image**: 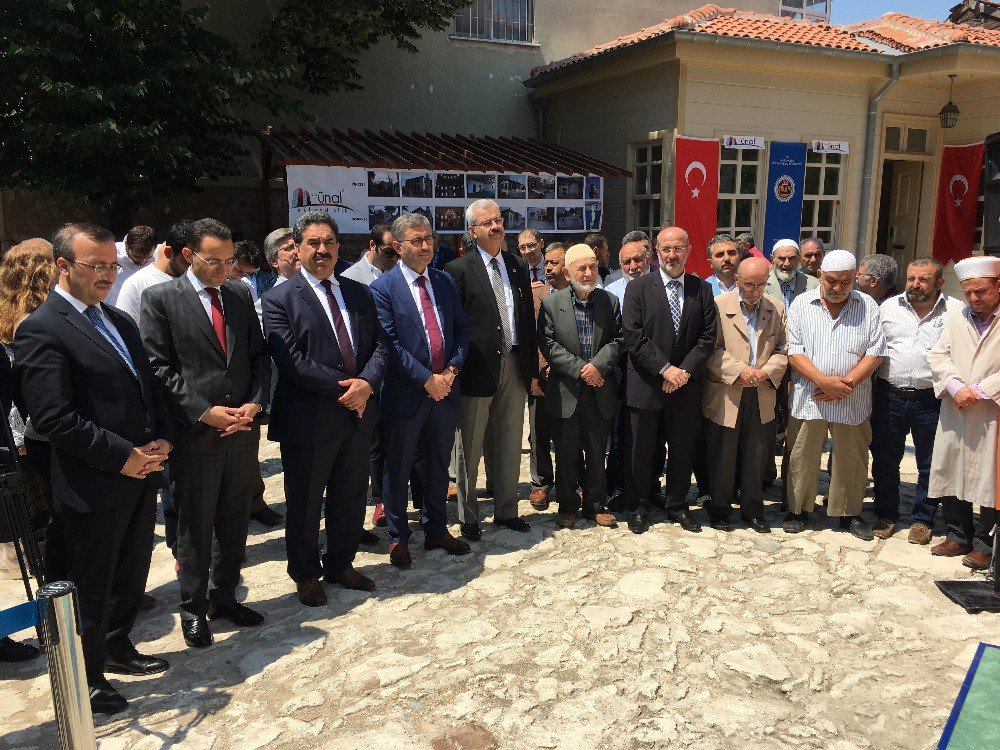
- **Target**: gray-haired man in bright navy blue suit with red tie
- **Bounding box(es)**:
[372,214,471,568]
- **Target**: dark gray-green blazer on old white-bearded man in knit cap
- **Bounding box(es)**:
[538,287,624,419]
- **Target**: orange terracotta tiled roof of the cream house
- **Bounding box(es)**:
[531,5,1000,77]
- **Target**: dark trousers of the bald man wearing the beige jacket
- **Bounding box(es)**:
[704,388,775,518]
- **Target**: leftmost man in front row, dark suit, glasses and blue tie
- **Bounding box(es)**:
[14,224,174,713]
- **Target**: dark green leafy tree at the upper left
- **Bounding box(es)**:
[0,0,468,230]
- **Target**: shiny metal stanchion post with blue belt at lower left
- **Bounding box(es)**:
[36,581,97,750]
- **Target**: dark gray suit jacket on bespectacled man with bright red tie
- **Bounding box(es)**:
[139,274,271,428]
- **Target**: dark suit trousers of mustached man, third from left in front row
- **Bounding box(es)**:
[281,423,374,583]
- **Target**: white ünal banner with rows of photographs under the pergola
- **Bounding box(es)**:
[286,166,604,234]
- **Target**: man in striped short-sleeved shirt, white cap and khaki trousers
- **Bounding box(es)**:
[782,250,886,541]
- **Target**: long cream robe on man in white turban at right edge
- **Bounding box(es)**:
[927,307,1000,508]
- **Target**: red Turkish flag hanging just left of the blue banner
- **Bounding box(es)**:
[674,135,719,278]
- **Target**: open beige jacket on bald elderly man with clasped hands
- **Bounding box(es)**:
[702,290,788,428]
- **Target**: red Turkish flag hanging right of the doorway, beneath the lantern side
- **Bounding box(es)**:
[934,143,983,264]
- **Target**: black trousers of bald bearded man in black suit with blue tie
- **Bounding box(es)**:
[625,383,702,513]
